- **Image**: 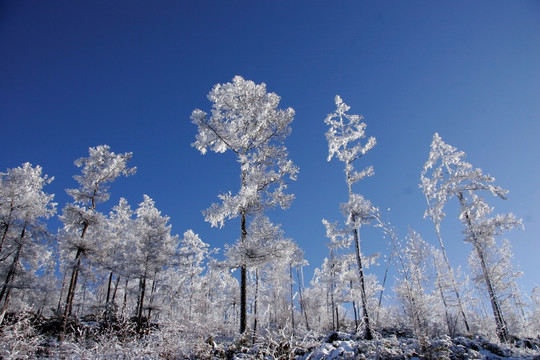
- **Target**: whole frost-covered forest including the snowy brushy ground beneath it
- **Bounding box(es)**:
[0,76,540,359]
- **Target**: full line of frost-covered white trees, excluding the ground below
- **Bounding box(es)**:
[0,77,540,342]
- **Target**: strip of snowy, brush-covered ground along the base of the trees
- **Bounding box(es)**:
[0,322,540,360]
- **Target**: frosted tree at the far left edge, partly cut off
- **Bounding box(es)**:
[0,163,56,324]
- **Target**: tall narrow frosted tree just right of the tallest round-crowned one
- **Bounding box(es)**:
[324,95,378,339]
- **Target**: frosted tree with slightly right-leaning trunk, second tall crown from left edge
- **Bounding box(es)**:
[59,145,135,333]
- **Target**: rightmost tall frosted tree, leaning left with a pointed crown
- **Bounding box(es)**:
[421,133,521,342]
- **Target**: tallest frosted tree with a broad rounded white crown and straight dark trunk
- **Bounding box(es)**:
[191,76,298,333]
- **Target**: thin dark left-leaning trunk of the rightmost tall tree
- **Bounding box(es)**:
[458,192,509,342]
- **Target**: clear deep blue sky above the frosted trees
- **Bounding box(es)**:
[0,0,540,293]
